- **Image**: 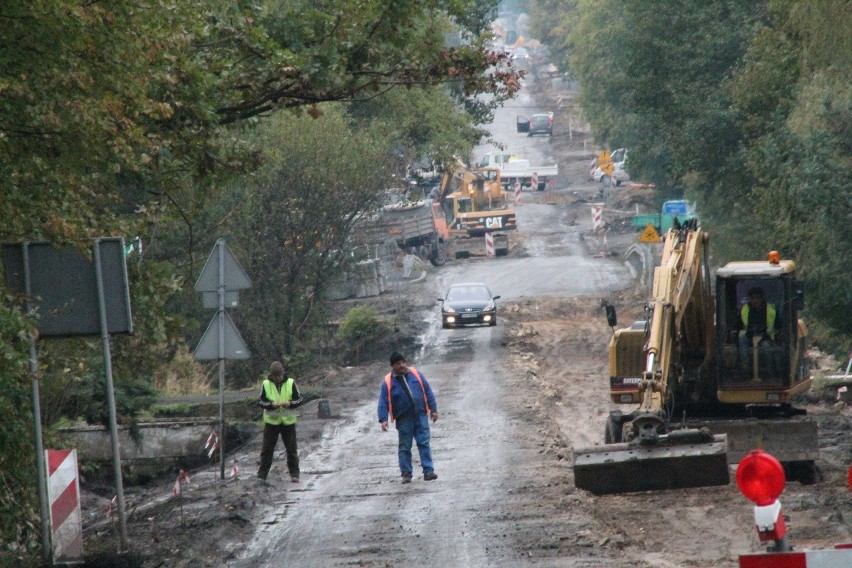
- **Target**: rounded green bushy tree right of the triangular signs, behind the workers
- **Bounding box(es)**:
[221,105,392,380]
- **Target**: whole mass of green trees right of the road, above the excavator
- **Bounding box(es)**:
[560,0,852,347]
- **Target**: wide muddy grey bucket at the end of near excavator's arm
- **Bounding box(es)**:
[574,434,731,495]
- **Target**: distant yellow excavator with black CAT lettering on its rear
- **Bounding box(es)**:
[439,163,517,258]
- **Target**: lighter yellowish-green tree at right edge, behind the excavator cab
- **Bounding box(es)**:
[733,1,852,344]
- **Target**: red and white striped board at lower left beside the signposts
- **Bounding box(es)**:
[44,450,83,562]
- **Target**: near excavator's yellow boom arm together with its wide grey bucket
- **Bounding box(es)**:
[573,222,730,495]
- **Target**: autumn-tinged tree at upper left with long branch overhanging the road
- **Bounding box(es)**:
[0,0,518,556]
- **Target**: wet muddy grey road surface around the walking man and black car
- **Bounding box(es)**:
[233,85,629,566]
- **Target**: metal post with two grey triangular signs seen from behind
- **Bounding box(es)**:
[195,239,251,479]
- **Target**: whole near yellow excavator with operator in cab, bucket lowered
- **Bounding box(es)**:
[573,219,818,495]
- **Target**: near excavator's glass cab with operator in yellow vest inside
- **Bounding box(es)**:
[716,261,810,398]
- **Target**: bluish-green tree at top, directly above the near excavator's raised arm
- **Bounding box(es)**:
[571,0,765,189]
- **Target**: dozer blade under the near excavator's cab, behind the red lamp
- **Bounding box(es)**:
[690,416,819,464]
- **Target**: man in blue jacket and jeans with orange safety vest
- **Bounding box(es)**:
[378,352,438,483]
